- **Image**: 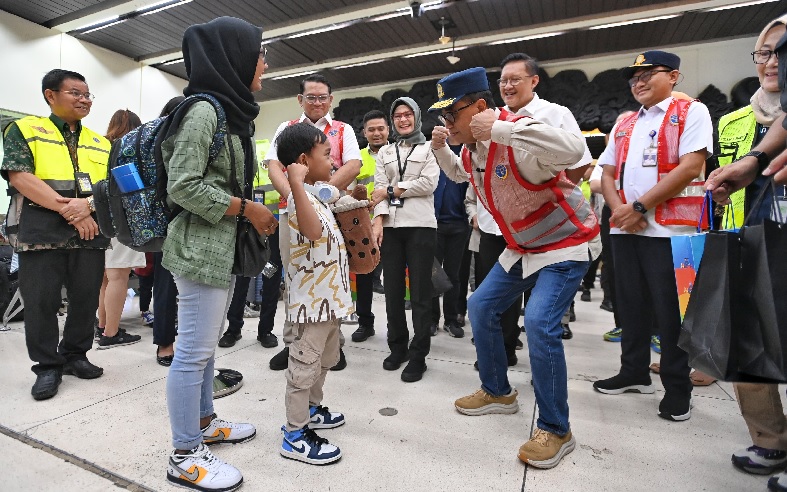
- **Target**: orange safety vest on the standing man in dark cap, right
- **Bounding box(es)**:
[615,99,708,228]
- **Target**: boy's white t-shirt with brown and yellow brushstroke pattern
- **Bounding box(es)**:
[285,192,355,323]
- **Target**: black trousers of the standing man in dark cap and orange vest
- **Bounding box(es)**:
[610,234,692,398]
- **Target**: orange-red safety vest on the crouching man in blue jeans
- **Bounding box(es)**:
[462,109,599,254]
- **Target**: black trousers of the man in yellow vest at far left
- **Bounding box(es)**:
[19,249,104,374]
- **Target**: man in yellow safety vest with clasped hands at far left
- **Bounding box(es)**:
[0,69,110,400]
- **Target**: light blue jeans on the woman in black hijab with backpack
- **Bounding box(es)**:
[167,275,235,449]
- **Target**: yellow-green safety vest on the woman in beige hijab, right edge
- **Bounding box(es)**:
[718,106,757,228]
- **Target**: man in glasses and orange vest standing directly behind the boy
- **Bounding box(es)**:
[264,74,364,371]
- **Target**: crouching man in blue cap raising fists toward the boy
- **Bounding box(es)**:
[429,68,600,468]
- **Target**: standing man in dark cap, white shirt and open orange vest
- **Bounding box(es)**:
[593,51,713,421]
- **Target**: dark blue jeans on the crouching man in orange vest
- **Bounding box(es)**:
[467,261,588,436]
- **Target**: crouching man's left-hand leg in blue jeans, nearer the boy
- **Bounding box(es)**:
[467,263,535,397]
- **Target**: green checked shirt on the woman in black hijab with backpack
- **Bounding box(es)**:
[161,101,243,289]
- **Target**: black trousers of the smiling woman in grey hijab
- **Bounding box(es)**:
[380,227,436,360]
